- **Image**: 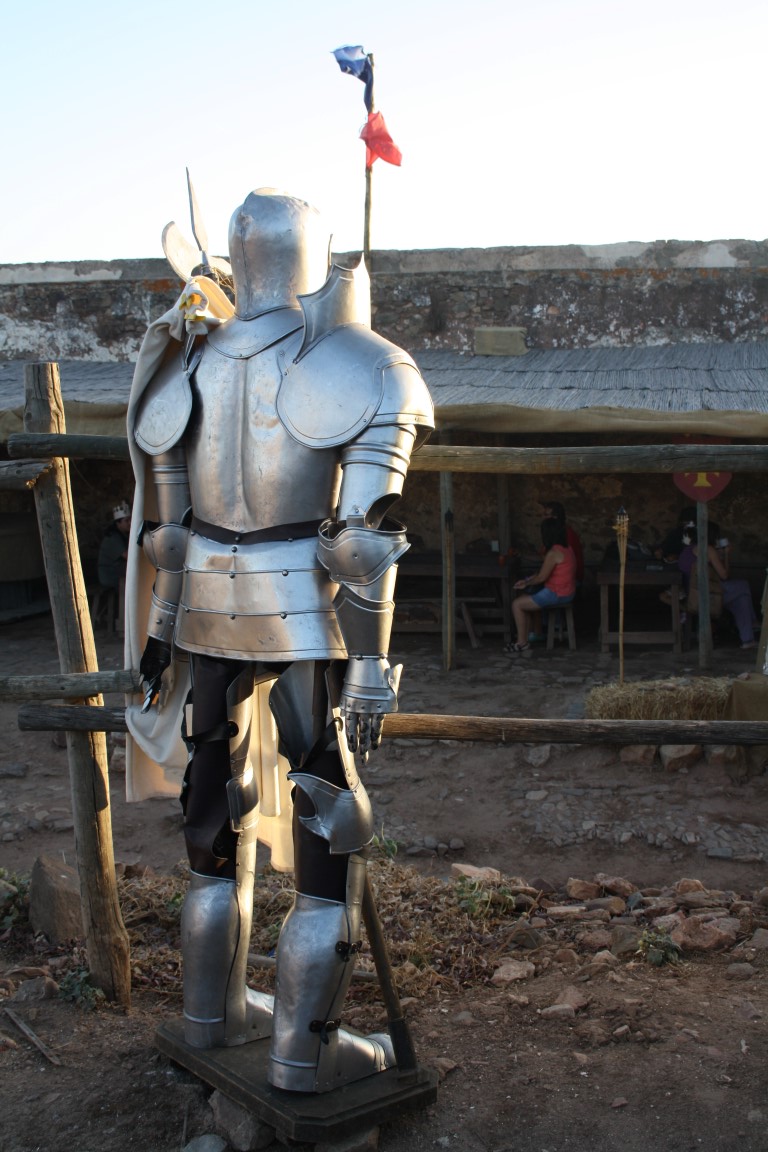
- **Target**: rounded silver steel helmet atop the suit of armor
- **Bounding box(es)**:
[229,188,330,320]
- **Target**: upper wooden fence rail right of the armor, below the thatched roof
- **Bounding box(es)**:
[409,444,768,476]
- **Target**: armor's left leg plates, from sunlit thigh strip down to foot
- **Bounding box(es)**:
[181,668,273,1048]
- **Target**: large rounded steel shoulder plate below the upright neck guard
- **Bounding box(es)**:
[277,324,420,448]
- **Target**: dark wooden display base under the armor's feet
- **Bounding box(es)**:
[155,1018,438,1144]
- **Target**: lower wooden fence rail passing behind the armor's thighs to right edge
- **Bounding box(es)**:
[18,704,768,745]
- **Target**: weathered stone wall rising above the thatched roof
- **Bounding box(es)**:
[0,241,768,361]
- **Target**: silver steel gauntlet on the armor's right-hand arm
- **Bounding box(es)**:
[340,655,403,761]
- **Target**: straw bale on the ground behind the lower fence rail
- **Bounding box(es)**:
[585,676,732,720]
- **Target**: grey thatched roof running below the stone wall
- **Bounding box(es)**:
[0,342,768,440]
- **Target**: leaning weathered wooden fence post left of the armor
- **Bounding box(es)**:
[24,364,130,1008]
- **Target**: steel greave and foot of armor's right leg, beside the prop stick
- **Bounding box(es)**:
[268,855,395,1092]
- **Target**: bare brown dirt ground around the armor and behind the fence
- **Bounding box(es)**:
[0,617,768,1152]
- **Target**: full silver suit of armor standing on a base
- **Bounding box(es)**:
[131,189,433,1092]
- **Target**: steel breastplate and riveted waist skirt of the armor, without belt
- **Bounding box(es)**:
[176,338,345,660]
